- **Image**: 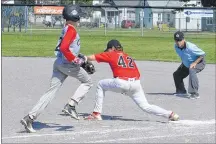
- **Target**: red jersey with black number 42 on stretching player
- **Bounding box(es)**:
[95,51,140,78]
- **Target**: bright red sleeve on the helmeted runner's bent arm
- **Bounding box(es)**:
[60,26,76,62]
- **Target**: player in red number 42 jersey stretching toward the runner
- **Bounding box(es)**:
[82,40,179,121]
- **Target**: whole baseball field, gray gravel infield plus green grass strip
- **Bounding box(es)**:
[1,29,216,144]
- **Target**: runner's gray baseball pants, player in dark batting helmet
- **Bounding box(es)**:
[29,59,93,119]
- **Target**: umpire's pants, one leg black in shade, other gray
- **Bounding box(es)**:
[173,59,205,93]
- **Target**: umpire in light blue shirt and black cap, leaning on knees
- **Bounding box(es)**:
[173,31,205,99]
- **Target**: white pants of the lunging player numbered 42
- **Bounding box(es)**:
[94,78,172,118]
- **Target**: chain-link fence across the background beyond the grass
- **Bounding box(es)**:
[1,5,216,36]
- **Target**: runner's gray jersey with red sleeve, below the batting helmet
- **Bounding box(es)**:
[55,24,80,62]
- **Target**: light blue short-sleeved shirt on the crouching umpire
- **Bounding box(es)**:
[174,42,205,68]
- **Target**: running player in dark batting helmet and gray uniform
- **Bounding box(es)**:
[21,5,93,132]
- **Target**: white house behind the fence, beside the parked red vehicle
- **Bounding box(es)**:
[93,0,143,28]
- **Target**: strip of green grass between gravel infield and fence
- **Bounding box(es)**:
[2,29,216,63]
